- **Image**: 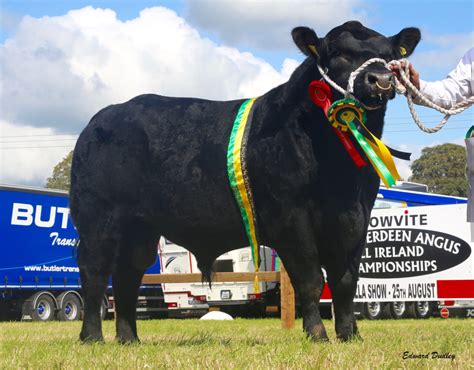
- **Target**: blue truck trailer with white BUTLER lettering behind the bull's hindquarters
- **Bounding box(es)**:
[0,185,166,321]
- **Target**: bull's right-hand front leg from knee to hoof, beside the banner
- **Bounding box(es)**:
[328,269,360,341]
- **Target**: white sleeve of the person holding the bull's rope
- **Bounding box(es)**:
[420,48,474,109]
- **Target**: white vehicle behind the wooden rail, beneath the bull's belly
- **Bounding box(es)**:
[159,238,279,317]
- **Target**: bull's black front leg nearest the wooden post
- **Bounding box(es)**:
[279,252,328,341]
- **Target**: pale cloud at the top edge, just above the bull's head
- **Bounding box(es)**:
[187,0,368,50]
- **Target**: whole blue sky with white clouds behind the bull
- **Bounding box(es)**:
[0,0,474,186]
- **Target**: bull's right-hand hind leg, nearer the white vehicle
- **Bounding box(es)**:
[112,223,159,343]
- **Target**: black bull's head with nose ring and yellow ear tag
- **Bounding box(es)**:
[292,21,420,107]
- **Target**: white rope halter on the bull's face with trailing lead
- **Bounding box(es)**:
[318,58,474,134]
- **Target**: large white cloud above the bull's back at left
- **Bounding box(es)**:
[0,7,298,188]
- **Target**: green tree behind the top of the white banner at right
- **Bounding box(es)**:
[409,144,467,197]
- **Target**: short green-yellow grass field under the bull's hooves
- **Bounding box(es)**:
[0,319,474,369]
